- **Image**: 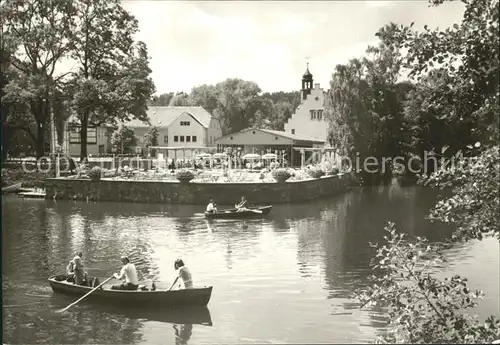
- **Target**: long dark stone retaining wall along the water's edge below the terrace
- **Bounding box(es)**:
[45,175,352,205]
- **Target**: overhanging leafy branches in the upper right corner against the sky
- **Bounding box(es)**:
[377,0,500,154]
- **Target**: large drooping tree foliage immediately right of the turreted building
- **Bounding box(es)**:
[326,38,408,183]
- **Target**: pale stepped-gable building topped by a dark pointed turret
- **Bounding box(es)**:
[285,63,329,142]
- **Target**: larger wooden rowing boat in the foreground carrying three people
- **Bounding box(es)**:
[48,275,212,307]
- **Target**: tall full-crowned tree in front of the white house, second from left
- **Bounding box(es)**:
[67,0,154,159]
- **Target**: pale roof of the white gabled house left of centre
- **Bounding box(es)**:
[126,107,212,128]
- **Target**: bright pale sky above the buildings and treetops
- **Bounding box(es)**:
[122,0,464,94]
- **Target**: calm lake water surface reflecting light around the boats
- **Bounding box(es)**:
[2,187,500,344]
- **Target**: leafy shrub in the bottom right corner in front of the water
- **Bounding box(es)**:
[358,223,500,344]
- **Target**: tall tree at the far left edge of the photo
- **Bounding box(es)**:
[0,0,75,157]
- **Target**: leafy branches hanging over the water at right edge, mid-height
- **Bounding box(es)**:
[421,143,500,240]
